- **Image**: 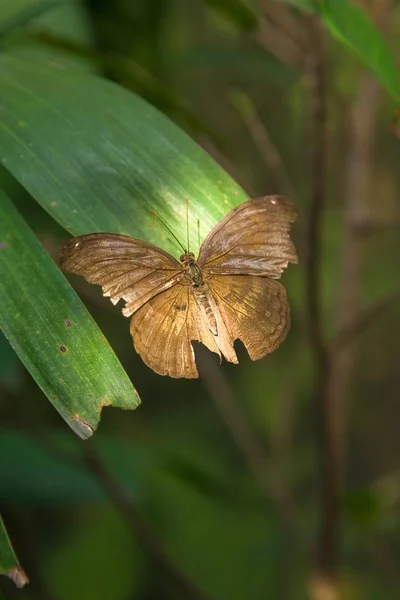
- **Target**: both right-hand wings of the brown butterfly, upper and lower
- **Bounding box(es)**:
[198,196,297,362]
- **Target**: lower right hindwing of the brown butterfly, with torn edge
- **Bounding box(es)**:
[208,275,290,362]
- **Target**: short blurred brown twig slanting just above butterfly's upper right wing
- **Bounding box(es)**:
[230,90,296,198]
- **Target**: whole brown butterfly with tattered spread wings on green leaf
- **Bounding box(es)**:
[61,196,297,378]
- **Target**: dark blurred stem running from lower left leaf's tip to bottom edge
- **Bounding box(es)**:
[83,442,210,600]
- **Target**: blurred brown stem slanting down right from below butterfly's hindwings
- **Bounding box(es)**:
[196,346,298,538]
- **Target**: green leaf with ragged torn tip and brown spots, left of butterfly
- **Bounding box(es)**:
[0,190,139,438]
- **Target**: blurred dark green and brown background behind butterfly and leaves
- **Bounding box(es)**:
[0,0,400,600]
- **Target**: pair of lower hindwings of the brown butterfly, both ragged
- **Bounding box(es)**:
[130,275,290,378]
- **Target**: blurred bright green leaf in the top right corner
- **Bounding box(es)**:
[320,0,400,102]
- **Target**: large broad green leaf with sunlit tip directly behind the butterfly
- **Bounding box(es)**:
[0,55,247,255]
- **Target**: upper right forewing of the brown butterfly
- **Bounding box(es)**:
[198,196,297,279]
